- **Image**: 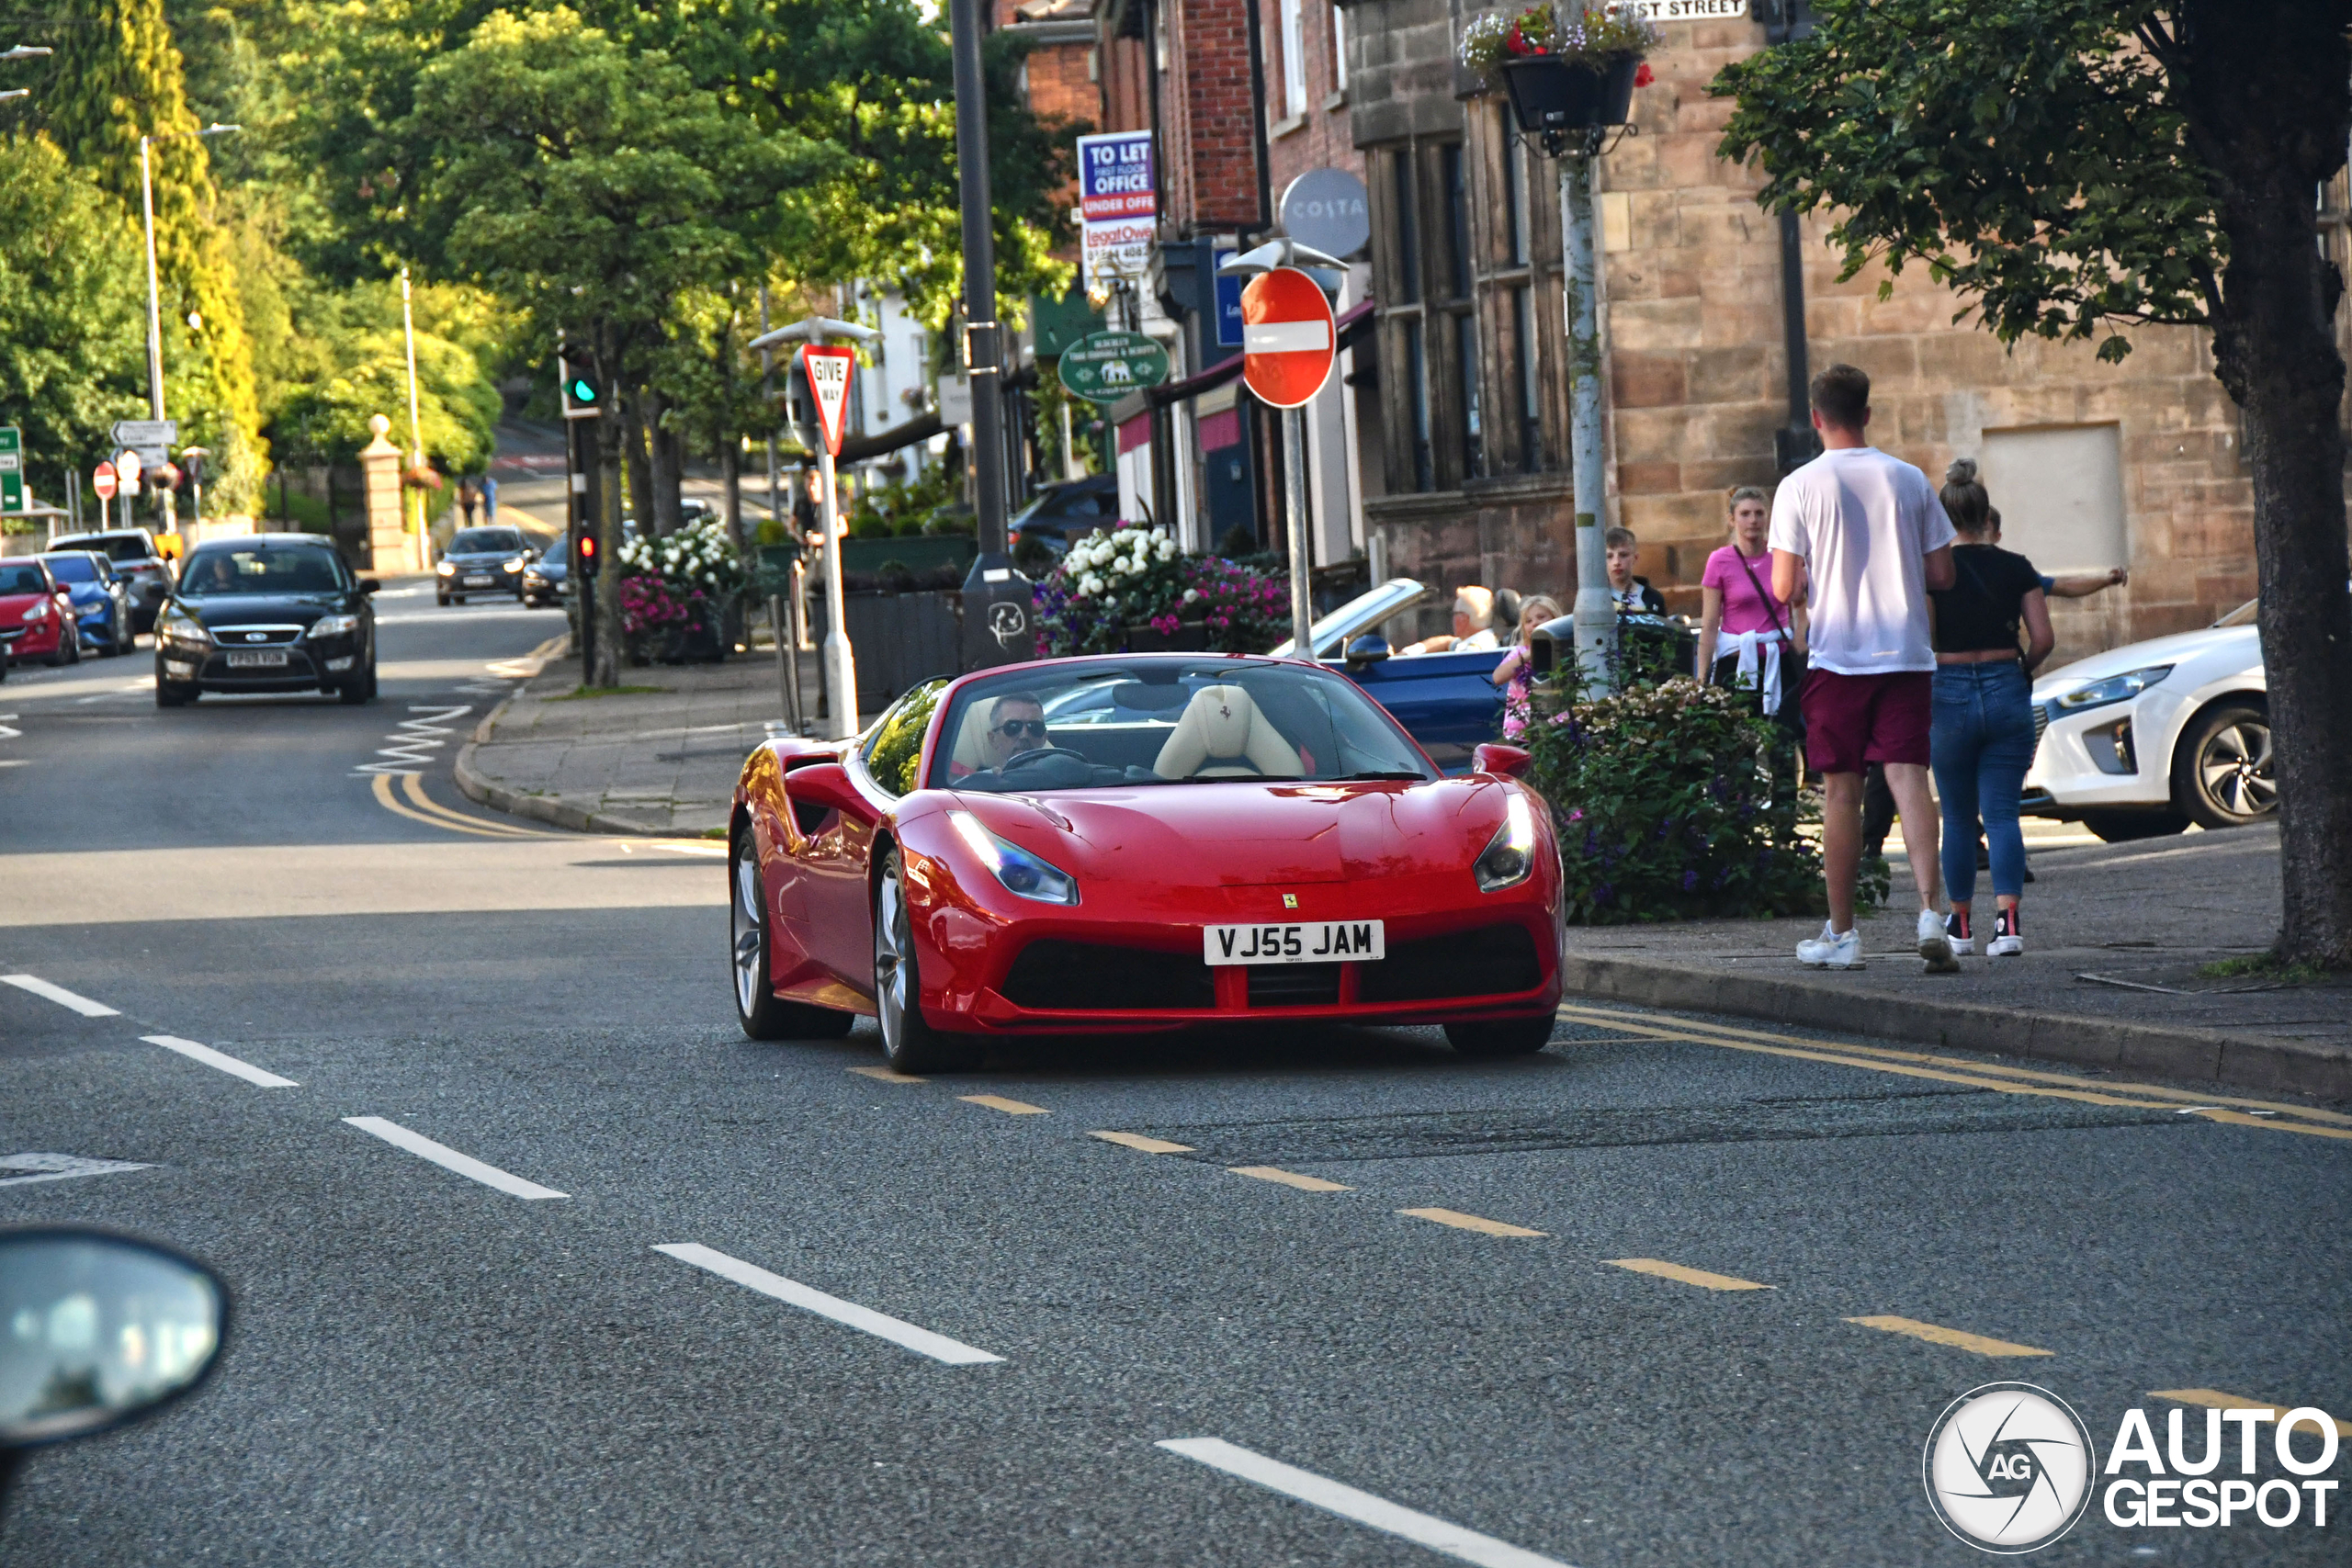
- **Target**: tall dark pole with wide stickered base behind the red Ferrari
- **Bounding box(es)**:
[948,0,1037,670]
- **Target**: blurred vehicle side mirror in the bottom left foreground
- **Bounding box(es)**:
[0,1227,228,1448]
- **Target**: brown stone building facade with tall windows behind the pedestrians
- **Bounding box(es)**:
[1348,0,2286,659]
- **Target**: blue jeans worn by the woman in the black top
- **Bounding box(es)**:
[1928,659,2034,908]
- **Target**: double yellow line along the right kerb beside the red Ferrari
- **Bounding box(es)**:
[1559,1006,2352,1140]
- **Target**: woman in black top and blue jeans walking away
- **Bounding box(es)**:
[1928,458,2055,959]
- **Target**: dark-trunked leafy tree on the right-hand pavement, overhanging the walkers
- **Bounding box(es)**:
[1713,0,2352,968]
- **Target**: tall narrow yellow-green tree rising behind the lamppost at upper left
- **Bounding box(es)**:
[40,0,264,510]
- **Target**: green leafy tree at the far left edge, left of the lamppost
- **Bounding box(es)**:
[0,134,146,505]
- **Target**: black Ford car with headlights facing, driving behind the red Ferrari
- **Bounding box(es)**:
[155,534,379,707]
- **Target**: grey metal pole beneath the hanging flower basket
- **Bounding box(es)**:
[1555,127,1618,696]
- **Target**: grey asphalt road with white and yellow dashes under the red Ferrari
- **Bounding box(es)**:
[0,594,2352,1568]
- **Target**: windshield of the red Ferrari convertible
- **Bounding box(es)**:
[932,659,1437,795]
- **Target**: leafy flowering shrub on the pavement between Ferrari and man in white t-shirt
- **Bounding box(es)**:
[1521,677,1886,926]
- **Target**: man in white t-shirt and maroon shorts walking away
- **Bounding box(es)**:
[1771,365,1959,974]
